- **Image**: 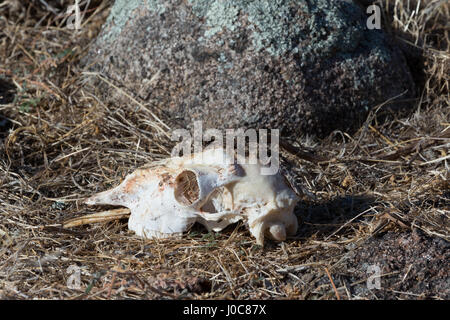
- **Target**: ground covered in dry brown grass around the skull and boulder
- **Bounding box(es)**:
[0,0,450,299]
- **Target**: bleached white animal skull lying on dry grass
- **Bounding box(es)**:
[86,149,299,245]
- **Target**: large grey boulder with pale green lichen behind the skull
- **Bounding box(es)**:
[85,0,414,136]
